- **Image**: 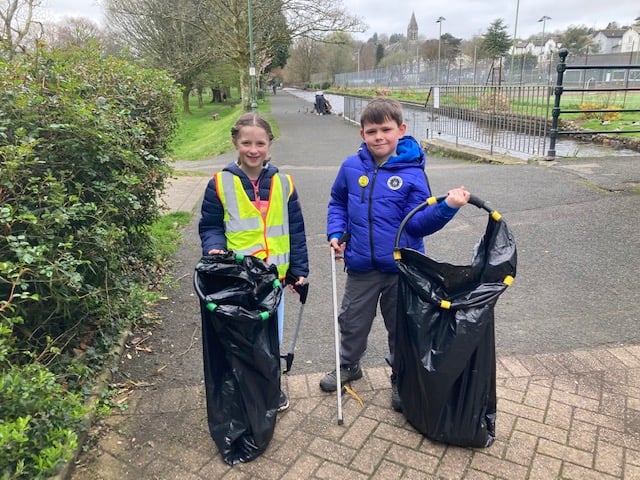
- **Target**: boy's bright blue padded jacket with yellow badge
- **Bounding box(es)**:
[327,136,458,272]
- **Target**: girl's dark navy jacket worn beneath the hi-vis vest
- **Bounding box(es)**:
[198,162,309,277]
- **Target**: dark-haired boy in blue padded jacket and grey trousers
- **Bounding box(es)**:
[320,98,470,411]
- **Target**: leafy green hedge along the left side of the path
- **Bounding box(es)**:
[0,47,179,479]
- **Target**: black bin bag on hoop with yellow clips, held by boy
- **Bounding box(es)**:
[393,195,517,448]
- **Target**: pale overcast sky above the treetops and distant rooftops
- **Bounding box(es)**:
[43,0,640,40]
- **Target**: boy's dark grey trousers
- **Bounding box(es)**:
[338,271,398,365]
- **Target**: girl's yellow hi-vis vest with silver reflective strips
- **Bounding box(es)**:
[214,172,293,278]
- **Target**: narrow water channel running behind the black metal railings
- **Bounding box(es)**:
[285,88,640,160]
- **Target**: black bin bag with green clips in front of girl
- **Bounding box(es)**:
[194,252,282,465]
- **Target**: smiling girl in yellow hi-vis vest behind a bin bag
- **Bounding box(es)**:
[198,113,309,411]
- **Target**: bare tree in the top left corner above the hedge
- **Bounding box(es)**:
[0,0,41,58]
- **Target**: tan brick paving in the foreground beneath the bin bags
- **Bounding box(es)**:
[73,346,640,480]
